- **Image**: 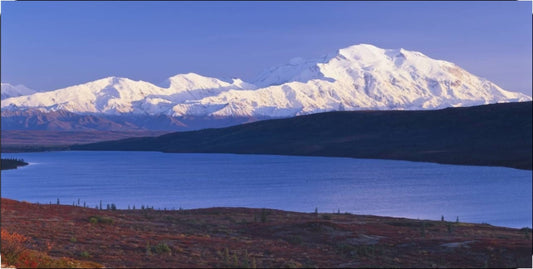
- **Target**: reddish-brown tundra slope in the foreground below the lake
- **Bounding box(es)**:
[1,198,532,268]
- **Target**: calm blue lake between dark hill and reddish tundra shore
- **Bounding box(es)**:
[1,151,532,228]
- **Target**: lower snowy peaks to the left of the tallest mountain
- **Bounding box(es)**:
[2,73,254,115]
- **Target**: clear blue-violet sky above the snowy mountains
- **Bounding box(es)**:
[1,1,532,96]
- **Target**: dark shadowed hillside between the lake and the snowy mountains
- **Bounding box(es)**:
[72,102,532,170]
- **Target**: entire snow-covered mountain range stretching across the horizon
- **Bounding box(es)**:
[1,44,531,128]
